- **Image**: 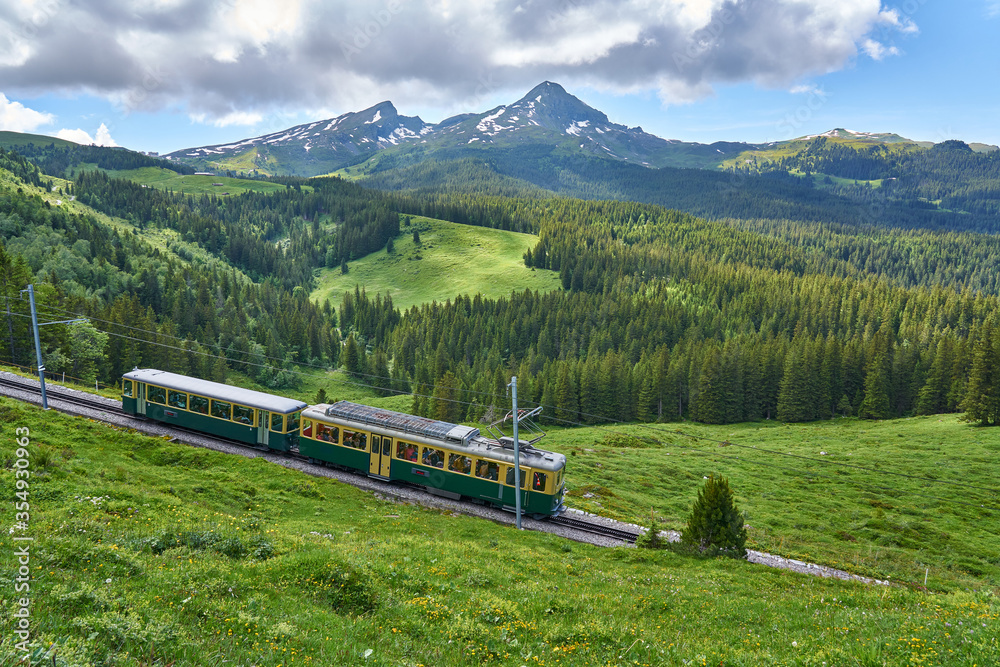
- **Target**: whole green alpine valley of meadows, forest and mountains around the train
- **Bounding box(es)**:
[0,83,1000,665]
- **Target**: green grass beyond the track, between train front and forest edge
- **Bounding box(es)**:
[545,415,1000,590]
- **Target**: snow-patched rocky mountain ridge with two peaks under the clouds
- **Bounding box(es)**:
[166,81,753,176]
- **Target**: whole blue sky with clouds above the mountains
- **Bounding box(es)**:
[0,0,1000,153]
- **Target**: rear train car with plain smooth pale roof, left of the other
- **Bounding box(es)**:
[122,368,307,452]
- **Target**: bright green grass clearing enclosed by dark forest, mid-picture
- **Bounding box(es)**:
[312,217,560,309]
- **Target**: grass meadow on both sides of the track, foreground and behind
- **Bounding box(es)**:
[0,399,1000,667]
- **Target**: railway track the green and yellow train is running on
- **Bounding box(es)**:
[0,375,638,544]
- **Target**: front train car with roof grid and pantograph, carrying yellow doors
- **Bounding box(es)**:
[299,401,566,517]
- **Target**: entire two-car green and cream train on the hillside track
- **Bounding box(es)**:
[122,368,566,518]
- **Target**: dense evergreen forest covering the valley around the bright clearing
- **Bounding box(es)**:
[0,142,1000,425]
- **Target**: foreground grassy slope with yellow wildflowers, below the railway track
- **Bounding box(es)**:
[0,399,1000,667]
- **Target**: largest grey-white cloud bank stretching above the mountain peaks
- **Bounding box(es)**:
[0,0,920,122]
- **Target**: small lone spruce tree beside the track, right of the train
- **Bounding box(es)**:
[681,475,747,558]
